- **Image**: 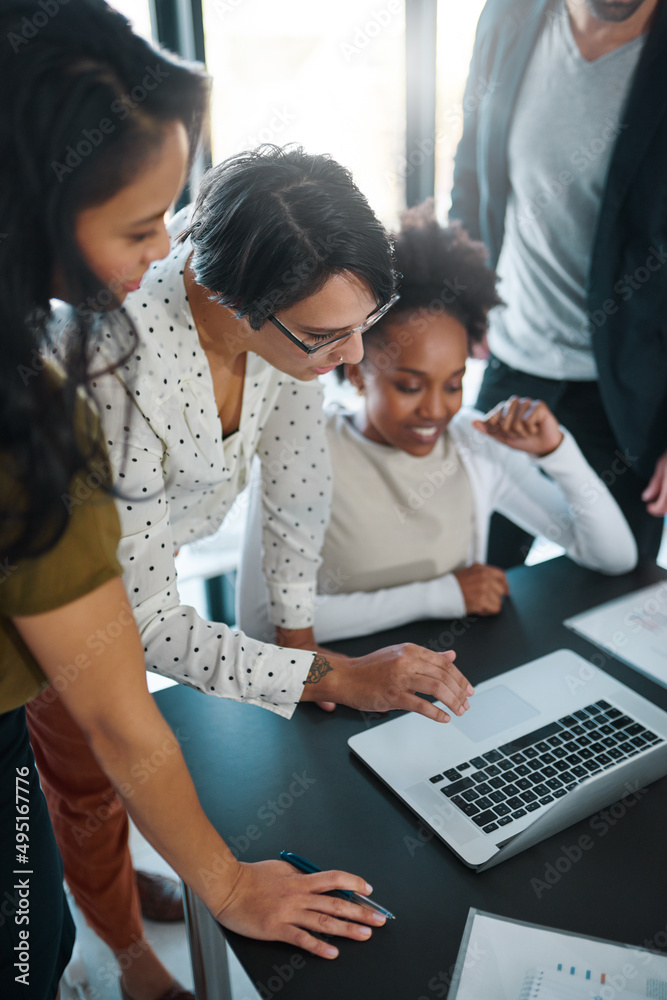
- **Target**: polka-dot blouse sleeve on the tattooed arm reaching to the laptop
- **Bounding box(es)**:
[90,375,314,718]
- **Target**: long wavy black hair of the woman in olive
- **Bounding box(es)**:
[0,0,208,560]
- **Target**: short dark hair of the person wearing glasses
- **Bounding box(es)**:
[181,145,395,330]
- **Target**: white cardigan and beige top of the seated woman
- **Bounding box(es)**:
[239,408,637,642]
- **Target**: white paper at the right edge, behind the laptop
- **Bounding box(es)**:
[563,580,667,687]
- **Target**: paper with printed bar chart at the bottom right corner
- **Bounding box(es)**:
[448,908,667,1000]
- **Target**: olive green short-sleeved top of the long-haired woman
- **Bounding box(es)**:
[0,450,122,712]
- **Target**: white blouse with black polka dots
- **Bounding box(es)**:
[56,216,331,718]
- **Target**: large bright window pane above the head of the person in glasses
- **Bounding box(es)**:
[203,0,405,226]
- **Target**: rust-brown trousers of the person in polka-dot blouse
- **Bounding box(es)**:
[26,688,144,951]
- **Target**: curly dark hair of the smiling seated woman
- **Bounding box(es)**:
[364,198,502,344]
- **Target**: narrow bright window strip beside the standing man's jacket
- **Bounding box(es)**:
[435,0,485,216]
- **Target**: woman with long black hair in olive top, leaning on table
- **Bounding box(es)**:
[0,0,394,998]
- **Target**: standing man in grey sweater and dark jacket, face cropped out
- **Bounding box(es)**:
[450,0,667,567]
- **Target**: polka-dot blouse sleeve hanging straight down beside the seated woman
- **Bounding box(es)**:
[258,380,332,629]
